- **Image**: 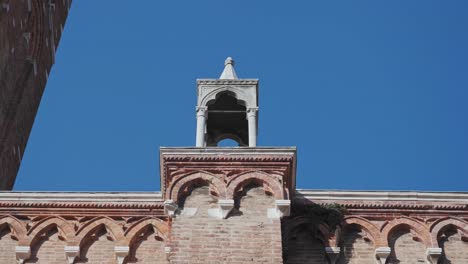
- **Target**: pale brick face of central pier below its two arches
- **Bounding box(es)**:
[171,187,282,263]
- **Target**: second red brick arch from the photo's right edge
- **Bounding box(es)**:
[381,217,431,247]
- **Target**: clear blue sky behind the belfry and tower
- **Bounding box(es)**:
[15,0,468,191]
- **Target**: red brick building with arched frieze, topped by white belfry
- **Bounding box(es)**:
[0,0,468,264]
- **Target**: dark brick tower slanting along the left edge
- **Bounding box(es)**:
[0,0,71,190]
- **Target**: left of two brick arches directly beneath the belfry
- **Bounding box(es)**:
[166,171,226,202]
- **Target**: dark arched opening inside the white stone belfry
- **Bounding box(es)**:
[206,91,249,146]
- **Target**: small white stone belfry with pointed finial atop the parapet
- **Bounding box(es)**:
[196,57,258,147]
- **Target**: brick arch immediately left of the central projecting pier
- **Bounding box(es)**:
[125,218,169,246]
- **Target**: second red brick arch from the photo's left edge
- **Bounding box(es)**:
[28,216,75,245]
